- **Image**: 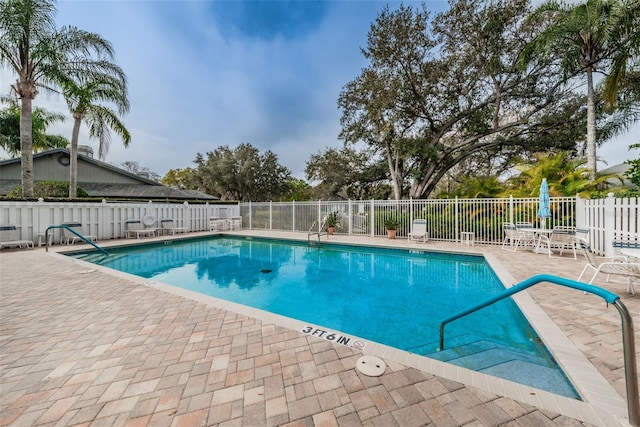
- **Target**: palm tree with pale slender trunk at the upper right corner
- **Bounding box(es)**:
[521,0,640,181]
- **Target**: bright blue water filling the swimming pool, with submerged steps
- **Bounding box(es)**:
[71,237,579,398]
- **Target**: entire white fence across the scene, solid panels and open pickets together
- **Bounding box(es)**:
[0,196,640,256]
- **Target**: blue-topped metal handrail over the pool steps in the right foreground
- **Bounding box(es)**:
[440,274,640,427]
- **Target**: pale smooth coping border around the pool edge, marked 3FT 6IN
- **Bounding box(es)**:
[50,230,628,426]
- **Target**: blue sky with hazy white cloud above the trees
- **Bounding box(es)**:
[0,0,638,178]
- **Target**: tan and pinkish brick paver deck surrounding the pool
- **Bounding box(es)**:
[0,233,640,427]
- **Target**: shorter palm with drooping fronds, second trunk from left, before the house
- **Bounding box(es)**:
[62,65,131,198]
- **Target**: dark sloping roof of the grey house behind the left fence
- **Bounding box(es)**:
[0,148,219,200]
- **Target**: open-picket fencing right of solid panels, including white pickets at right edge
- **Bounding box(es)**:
[240,197,640,255]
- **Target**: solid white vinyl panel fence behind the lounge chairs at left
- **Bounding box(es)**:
[0,201,239,244]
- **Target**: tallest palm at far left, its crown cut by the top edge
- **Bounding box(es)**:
[0,0,113,197]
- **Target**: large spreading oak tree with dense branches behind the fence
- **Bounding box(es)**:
[338,0,586,198]
